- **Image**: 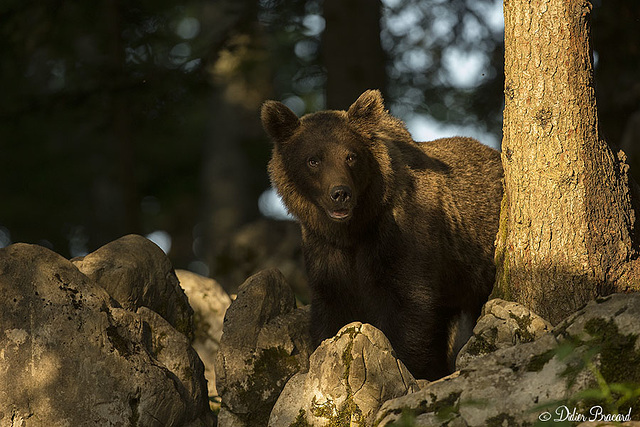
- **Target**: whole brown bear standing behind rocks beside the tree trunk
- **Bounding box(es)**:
[262,90,502,380]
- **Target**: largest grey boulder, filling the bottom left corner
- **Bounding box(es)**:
[0,244,213,427]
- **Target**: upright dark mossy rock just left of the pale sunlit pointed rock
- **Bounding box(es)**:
[216,269,311,427]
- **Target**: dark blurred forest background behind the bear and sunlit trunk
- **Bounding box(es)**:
[0,0,640,290]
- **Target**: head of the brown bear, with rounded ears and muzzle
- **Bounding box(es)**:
[262,90,412,237]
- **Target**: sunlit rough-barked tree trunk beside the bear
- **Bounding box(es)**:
[494,0,640,323]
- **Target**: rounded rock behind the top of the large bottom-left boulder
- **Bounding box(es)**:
[72,234,193,338]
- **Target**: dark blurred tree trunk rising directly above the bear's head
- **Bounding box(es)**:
[322,0,386,110]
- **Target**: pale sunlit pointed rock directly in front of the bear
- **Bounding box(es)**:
[269,322,418,427]
